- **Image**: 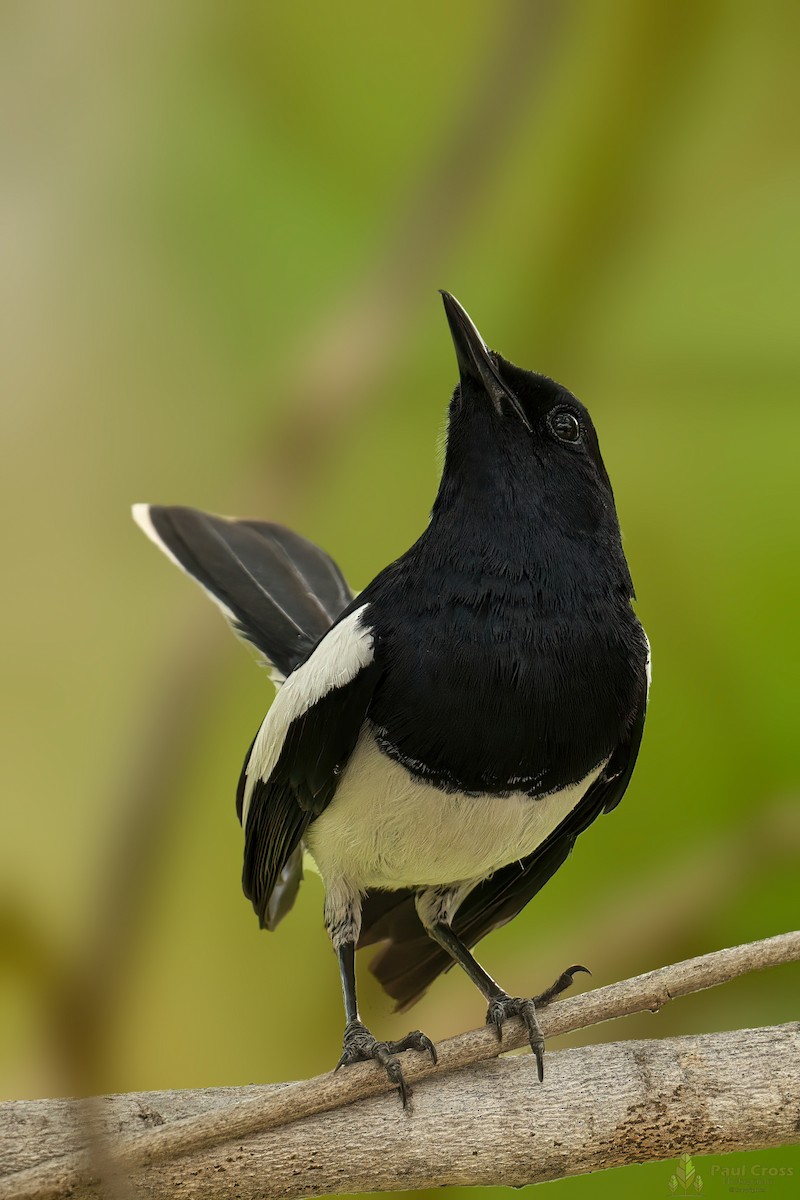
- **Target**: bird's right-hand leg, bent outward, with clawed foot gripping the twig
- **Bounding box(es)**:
[416,887,587,1082]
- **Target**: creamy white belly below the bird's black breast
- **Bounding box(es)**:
[306,726,604,890]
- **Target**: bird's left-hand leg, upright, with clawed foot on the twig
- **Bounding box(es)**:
[325,886,437,1108]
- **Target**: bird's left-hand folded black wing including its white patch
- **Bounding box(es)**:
[236,604,379,929]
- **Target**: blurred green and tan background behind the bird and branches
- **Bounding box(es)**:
[0,0,800,1200]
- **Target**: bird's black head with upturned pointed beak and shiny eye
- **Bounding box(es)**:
[434,292,619,540]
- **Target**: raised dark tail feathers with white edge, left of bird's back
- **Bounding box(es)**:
[133,504,353,682]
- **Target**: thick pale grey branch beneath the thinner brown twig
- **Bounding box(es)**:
[0,1025,800,1200]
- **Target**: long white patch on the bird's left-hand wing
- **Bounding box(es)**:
[242,604,374,828]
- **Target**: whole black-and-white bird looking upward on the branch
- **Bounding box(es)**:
[133,292,650,1106]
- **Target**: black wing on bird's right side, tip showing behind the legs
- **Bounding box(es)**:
[367,685,646,1009]
